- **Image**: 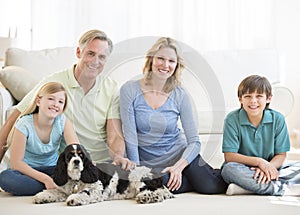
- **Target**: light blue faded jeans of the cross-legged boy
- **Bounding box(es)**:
[222,162,300,196]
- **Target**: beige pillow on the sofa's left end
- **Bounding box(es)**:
[0,66,39,101]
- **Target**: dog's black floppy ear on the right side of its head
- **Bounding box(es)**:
[80,145,98,183]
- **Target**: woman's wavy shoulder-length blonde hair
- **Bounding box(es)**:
[143,37,185,93]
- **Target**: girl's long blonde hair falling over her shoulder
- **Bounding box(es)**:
[7,82,68,147]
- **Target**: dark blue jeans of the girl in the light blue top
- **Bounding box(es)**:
[0,166,55,196]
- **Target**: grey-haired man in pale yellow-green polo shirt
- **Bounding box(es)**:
[0,30,135,169]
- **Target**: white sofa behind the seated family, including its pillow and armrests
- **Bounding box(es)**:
[0,37,292,171]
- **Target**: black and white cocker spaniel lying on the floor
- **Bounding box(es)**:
[33,144,174,206]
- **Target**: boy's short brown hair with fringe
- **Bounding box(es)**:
[238,75,272,108]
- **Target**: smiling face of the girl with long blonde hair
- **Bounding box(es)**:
[36,91,66,118]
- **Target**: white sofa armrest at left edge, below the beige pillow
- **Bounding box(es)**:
[0,86,16,126]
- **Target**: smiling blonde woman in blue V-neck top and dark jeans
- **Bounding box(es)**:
[120,37,227,194]
